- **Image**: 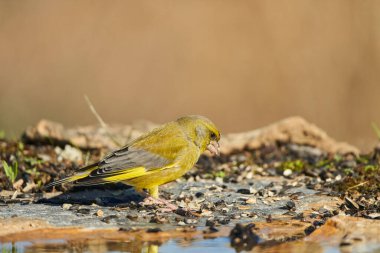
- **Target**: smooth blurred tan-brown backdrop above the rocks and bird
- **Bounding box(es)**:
[0,0,380,149]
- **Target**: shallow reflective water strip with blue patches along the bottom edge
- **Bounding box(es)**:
[0,237,380,253]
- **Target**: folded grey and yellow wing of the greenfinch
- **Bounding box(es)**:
[75,123,189,185]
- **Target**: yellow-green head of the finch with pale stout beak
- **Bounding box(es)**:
[177,115,220,155]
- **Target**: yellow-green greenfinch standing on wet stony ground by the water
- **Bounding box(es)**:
[47,115,220,199]
